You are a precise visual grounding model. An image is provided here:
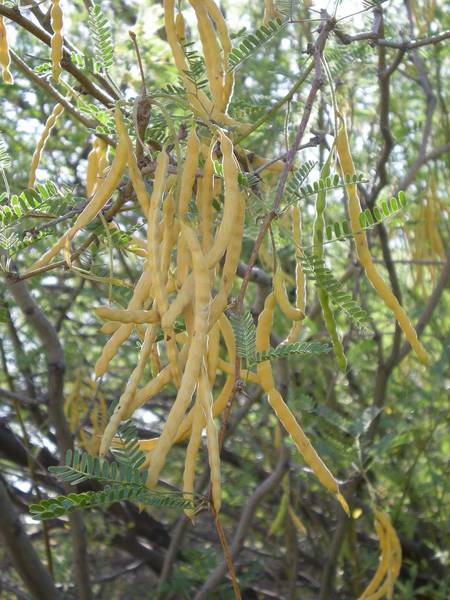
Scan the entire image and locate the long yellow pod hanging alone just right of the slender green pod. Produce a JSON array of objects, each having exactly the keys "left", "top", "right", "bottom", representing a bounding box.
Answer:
[{"left": 336, "top": 115, "right": 429, "bottom": 364}]
